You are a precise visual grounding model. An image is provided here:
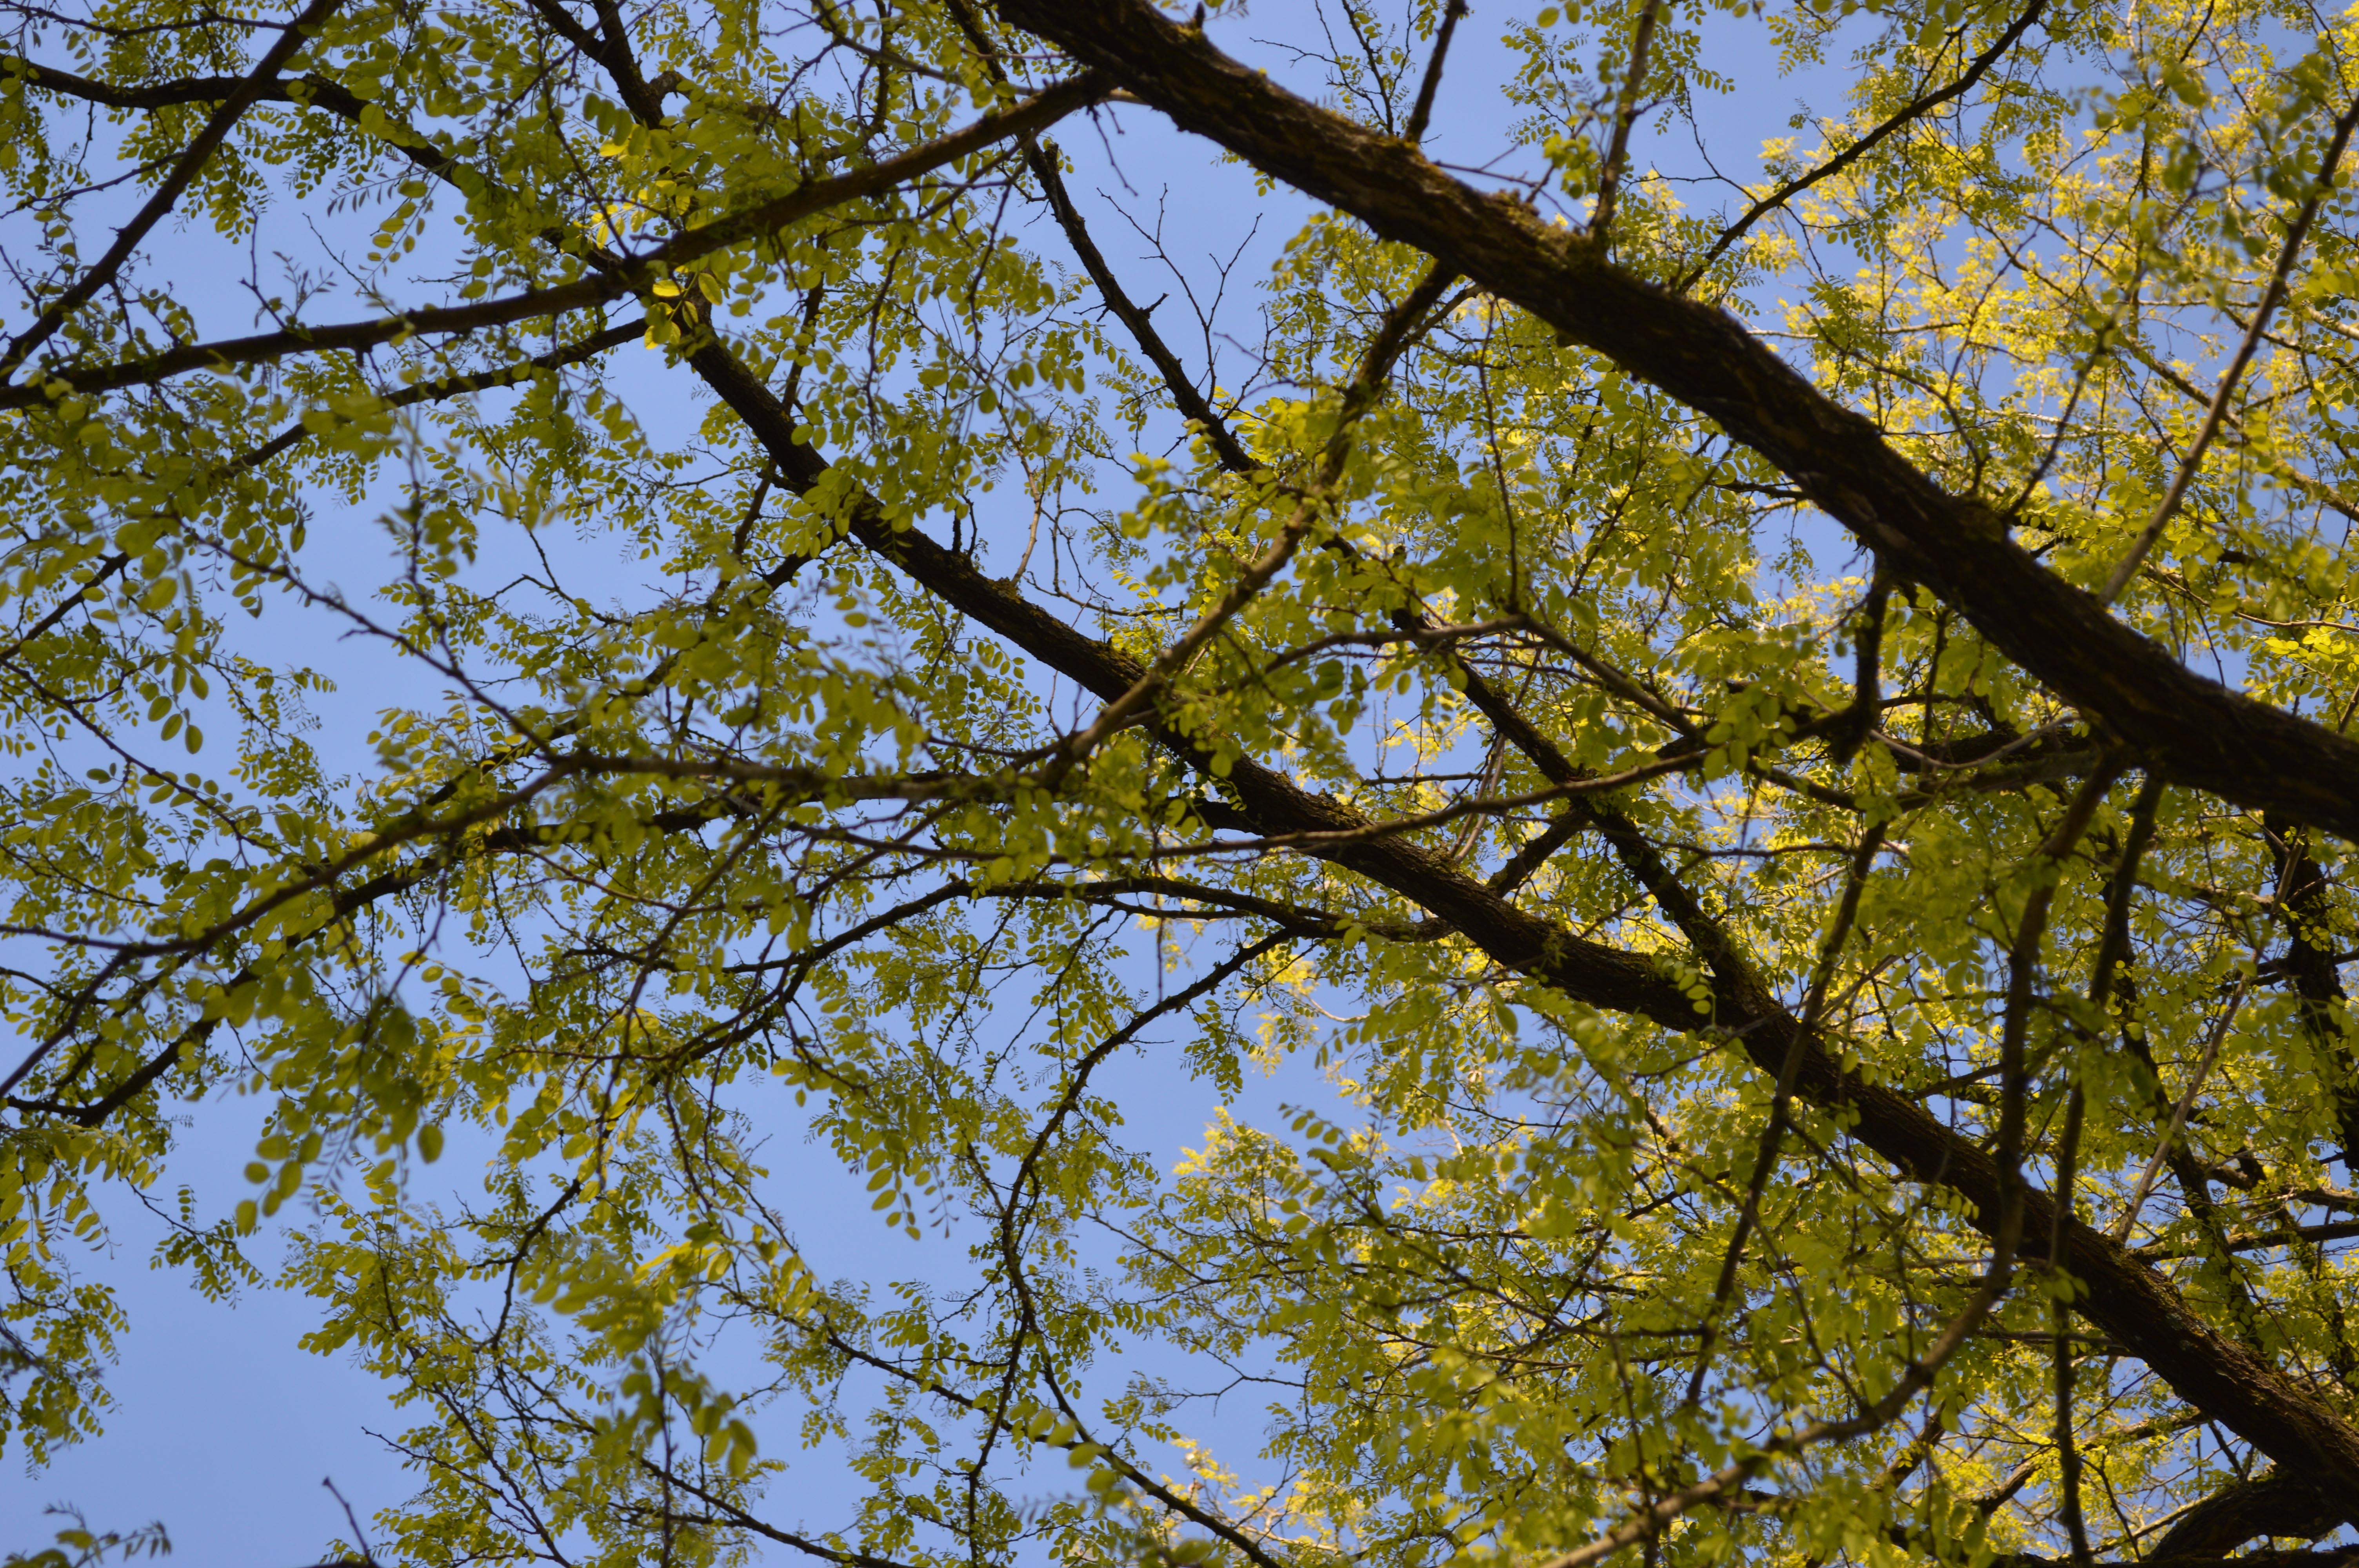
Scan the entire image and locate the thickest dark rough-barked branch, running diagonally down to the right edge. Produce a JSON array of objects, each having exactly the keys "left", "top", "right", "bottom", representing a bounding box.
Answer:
[{"left": 998, "top": 0, "right": 2359, "bottom": 837}]
